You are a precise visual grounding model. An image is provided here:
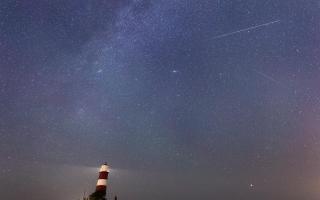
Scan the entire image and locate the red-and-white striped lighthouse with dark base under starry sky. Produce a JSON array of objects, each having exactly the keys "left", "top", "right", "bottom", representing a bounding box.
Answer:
[{"left": 89, "top": 163, "right": 110, "bottom": 200}]
